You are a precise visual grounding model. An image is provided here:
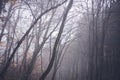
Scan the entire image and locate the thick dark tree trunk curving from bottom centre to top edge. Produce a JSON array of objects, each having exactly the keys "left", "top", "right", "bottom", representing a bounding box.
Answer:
[{"left": 39, "top": 0, "right": 73, "bottom": 80}]
